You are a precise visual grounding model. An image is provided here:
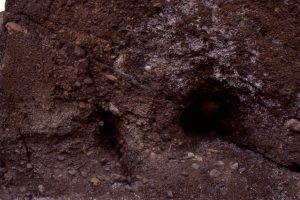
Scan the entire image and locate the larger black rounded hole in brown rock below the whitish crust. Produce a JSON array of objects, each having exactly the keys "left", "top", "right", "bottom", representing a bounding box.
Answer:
[{"left": 180, "top": 85, "right": 239, "bottom": 135}]
